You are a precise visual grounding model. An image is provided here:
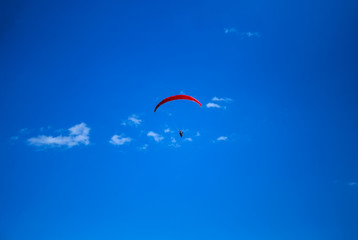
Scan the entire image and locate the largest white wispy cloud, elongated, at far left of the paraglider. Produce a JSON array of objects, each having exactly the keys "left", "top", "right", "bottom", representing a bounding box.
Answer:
[{"left": 27, "top": 123, "right": 90, "bottom": 147}]
